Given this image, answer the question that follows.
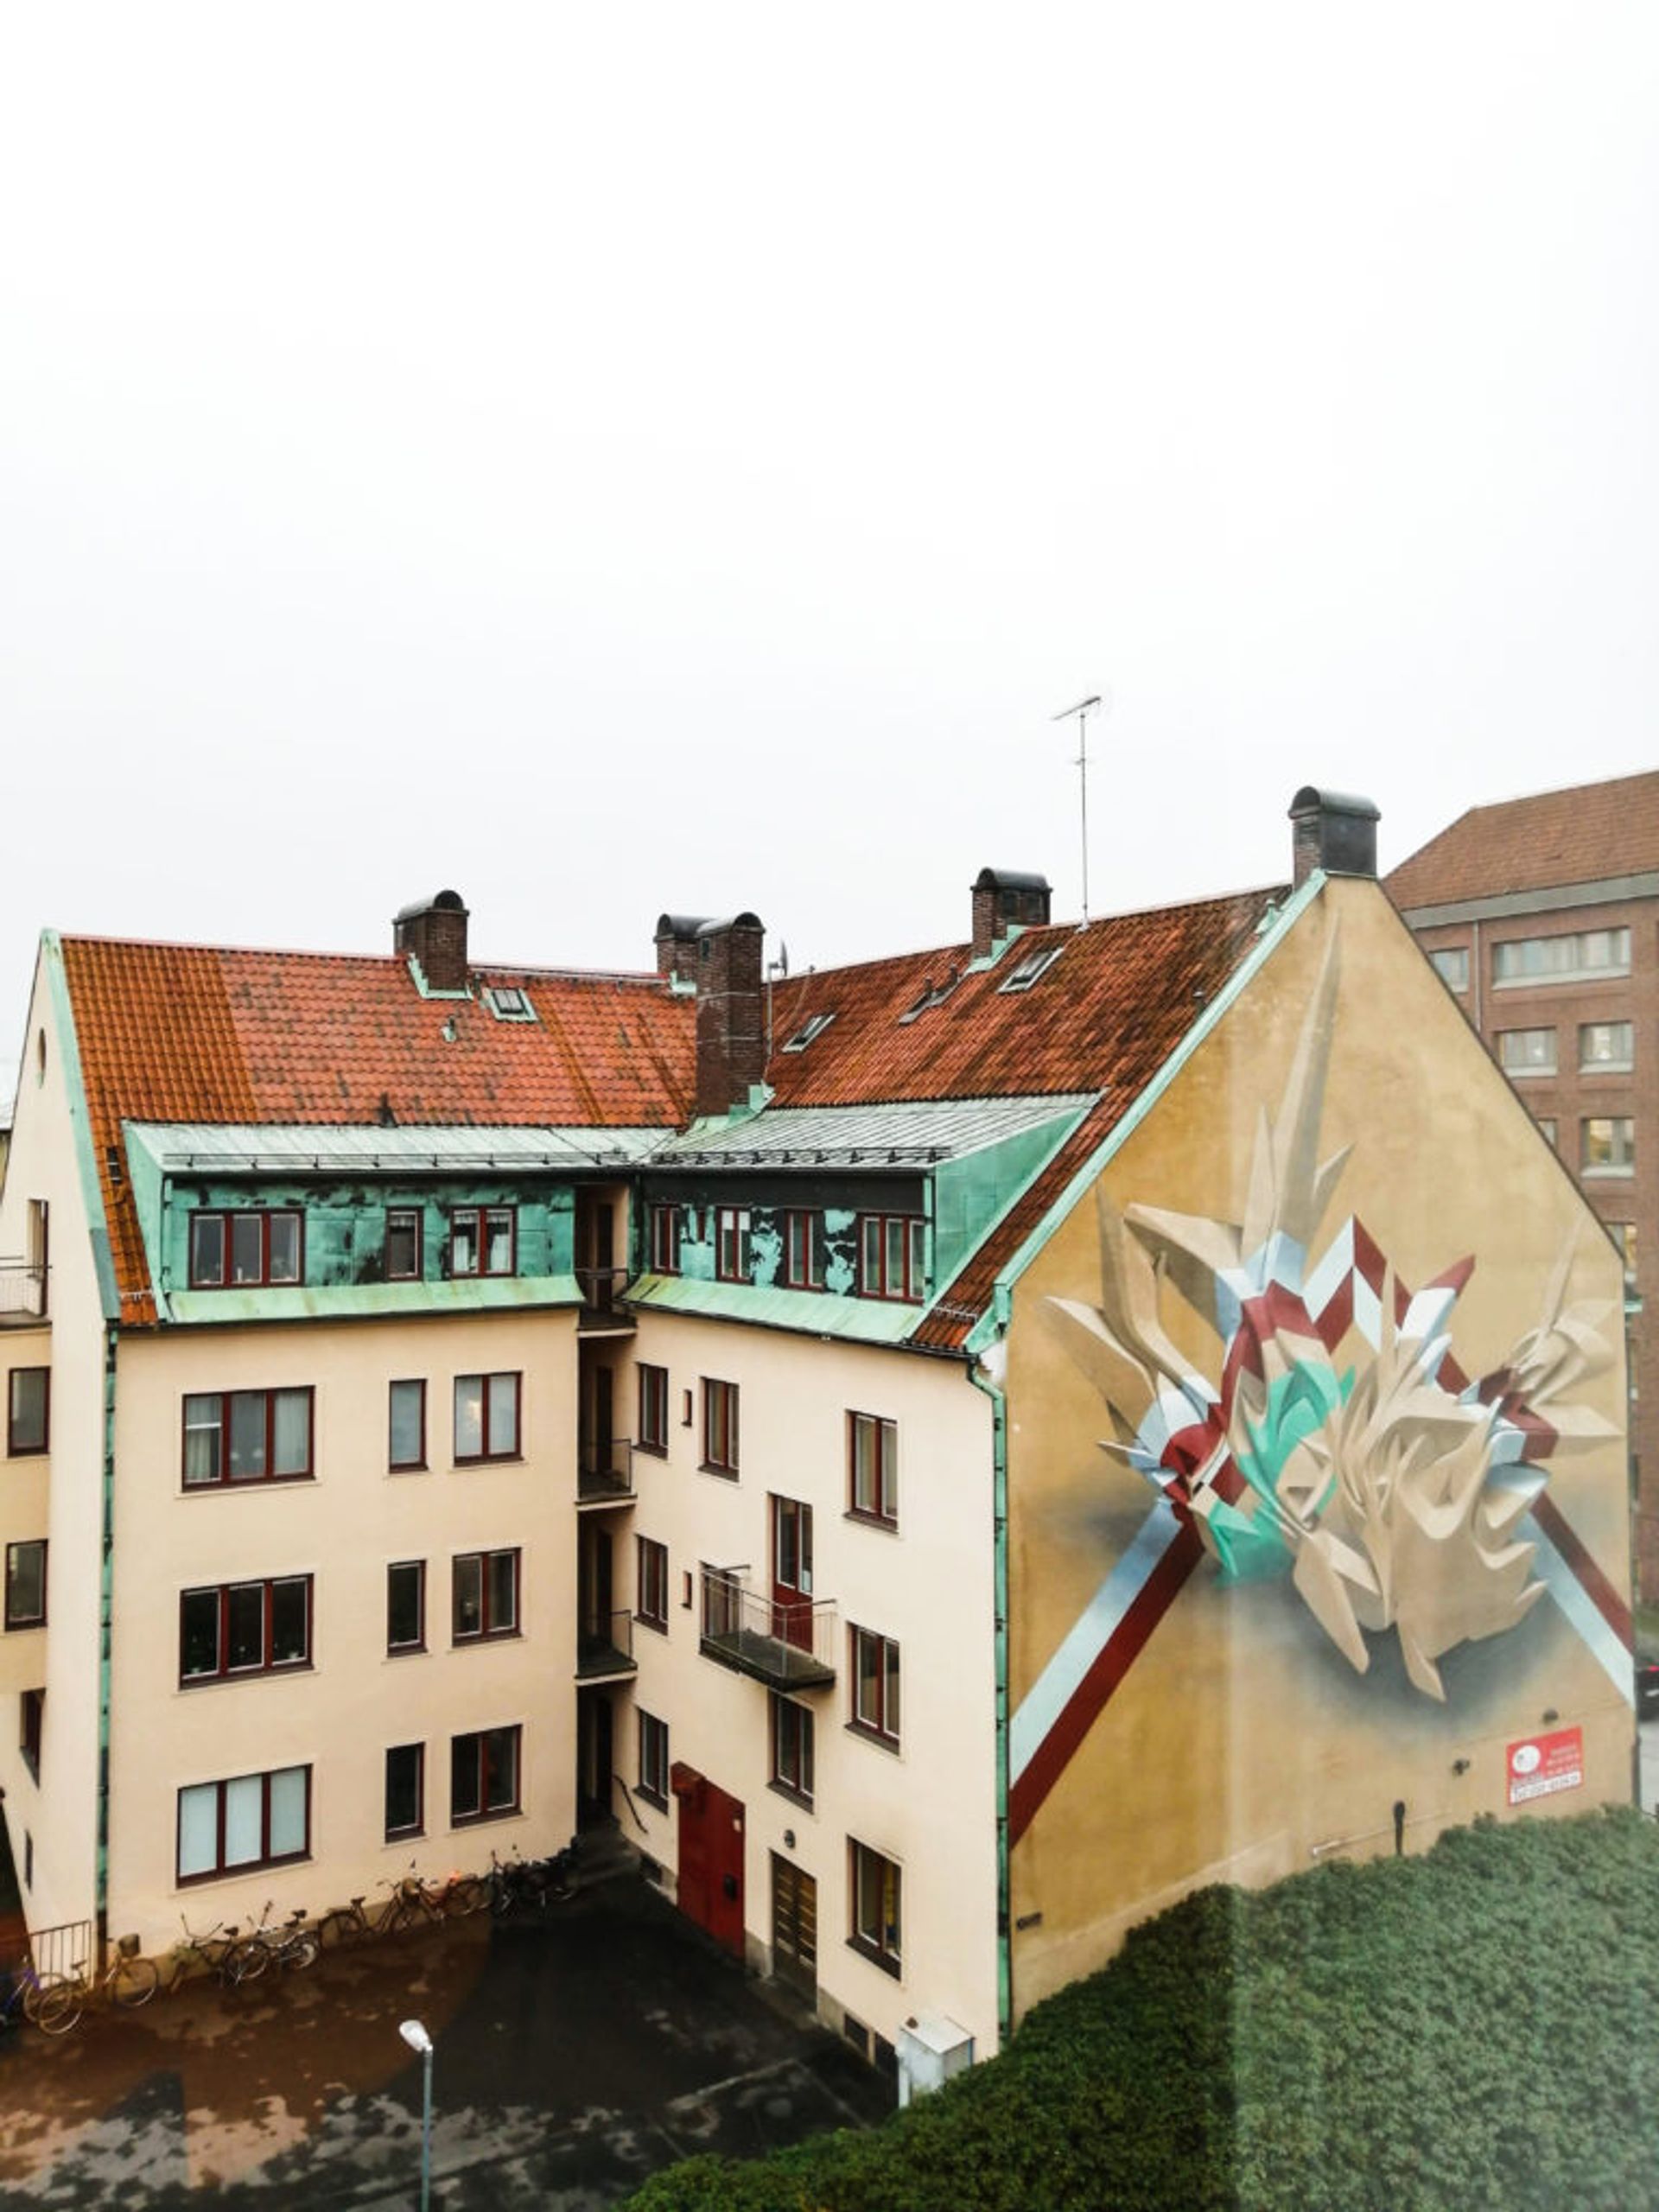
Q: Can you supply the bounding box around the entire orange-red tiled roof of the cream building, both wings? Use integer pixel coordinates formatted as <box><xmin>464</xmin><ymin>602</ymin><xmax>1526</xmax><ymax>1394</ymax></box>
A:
<box><xmin>62</xmin><ymin>887</ymin><xmax>1285</xmax><ymax>1351</ymax></box>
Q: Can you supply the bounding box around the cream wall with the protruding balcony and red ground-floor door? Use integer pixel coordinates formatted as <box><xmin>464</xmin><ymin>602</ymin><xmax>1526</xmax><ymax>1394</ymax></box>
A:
<box><xmin>617</xmin><ymin>1316</ymin><xmax>998</xmax><ymax>2055</ymax></box>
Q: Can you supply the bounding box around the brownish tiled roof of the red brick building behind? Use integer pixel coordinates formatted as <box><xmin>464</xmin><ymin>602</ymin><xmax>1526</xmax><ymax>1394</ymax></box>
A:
<box><xmin>1387</xmin><ymin>770</ymin><xmax>1659</xmax><ymax>909</ymax></box>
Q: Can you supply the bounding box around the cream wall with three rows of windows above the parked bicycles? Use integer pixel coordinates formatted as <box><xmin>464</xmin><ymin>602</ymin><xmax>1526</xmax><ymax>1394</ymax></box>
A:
<box><xmin>111</xmin><ymin>1312</ymin><xmax>577</xmax><ymax>1948</ymax></box>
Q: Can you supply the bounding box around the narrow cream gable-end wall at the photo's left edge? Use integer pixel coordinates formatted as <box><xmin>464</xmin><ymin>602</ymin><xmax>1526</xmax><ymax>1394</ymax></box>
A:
<box><xmin>0</xmin><ymin>956</ymin><xmax>104</xmax><ymax>1929</ymax></box>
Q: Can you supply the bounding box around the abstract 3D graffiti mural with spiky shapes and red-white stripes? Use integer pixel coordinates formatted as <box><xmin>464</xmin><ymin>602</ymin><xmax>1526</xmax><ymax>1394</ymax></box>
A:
<box><xmin>1011</xmin><ymin>931</ymin><xmax>1630</xmax><ymax>1838</ymax></box>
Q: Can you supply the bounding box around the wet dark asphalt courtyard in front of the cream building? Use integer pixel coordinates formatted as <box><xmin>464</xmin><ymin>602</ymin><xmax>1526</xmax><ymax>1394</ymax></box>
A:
<box><xmin>0</xmin><ymin>1876</ymin><xmax>892</xmax><ymax>2212</ymax></box>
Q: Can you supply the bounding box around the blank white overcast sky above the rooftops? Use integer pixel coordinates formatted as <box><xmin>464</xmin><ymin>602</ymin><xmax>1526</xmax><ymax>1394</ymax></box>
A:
<box><xmin>0</xmin><ymin>0</ymin><xmax>1659</xmax><ymax>1097</ymax></box>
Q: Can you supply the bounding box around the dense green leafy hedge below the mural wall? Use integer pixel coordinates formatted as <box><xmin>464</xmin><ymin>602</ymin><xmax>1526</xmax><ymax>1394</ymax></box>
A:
<box><xmin>628</xmin><ymin>1812</ymin><xmax>1659</xmax><ymax>2212</ymax></box>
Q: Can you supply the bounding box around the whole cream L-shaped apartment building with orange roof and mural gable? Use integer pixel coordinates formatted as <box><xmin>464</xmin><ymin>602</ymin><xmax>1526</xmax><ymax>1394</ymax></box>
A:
<box><xmin>0</xmin><ymin>791</ymin><xmax>1632</xmax><ymax>2086</ymax></box>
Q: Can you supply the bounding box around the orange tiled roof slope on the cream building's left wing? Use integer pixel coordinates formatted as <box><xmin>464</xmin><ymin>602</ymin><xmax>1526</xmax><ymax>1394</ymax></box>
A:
<box><xmin>62</xmin><ymin>938</ymin><xmax>695</xmax><ymax>1320</ymax></box>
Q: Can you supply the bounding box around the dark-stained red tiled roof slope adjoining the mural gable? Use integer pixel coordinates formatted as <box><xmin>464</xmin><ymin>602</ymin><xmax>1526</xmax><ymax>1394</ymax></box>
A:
<box><xmin>767</xmin><ymin>887</ymin><xmax>1285</xmax><ymax>1351</ymax></box>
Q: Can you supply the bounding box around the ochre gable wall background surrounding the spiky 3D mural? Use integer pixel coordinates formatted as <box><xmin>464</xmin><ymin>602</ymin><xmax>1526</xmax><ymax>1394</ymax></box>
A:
<box><xmin>1008</xmin><ymin>882</ymin><xmax>1635</xmax><ymax>2011</ymax></box>
